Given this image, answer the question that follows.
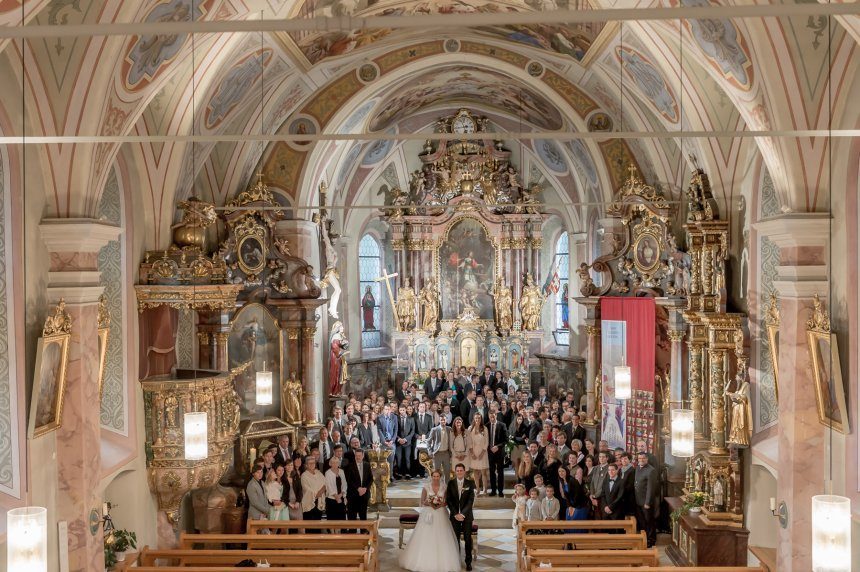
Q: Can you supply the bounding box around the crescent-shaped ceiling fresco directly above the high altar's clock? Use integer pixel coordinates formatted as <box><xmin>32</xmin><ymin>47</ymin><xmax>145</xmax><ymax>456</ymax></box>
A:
<box><xmin>370</xmin><ymin>66</ymin><xmax>563</xmax><ymax>131</ymax></box>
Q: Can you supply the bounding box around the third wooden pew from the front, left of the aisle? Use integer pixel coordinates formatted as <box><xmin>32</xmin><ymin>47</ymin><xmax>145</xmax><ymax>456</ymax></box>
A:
<box><xmin>137</xmin><ymin>548</ymin><xmax>368</xmax><ymax>572</ymax></box>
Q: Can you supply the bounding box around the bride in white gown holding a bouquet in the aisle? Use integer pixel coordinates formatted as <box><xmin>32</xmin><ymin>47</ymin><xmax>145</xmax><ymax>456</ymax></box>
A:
<box><xmin>400</xmin><ymin>469</ymin><xmax>460</xmax><ymax>572</ymax></box>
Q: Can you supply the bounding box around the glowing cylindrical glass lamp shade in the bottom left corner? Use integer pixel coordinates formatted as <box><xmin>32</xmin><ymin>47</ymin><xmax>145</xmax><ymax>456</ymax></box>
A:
<box><xmin>6</xmin><ymin>506</ymin><xmax>48</xmax><ymax>572</ymax></box>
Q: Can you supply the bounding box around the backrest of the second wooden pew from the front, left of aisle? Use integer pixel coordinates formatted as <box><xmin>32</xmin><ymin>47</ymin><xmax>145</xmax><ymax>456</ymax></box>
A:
<box><xmin>179</xmin><ymin>533</ymin><xmax>373</xmax><ymax>550</ymax></box>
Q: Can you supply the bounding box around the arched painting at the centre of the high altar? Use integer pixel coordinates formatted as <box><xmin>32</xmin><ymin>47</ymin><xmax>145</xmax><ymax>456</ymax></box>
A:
<box><xmin>439</xmin><ymin>218</ymin><xmax>496</xmax><ymax>320</ymax></box>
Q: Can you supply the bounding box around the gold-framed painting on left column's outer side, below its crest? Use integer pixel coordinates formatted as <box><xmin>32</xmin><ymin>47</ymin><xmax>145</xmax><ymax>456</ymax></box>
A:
<box><xmin>30</xmin><ymin>334</ymin><xmax>71</xmax><ymax>437</ymax></box>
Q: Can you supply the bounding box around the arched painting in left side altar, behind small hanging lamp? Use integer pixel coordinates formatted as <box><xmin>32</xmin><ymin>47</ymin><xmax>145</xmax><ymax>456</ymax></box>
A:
<box><xmin>227</xmin><ymin>304</ymin><xmax>281</xmax><ymax>417</ymax></box>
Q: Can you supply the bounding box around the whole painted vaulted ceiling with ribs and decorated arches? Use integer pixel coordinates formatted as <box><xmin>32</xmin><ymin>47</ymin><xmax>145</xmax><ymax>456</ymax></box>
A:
<box><xmin>0</xmin><ymin>0</ymin><xmax>860</xmax><ymax>246</ymax></box>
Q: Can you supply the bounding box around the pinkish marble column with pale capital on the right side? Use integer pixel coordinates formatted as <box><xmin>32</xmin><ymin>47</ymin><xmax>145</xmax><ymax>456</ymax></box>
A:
<box><xmin>755</xmin><ymin>213</ymin><xmax>832</xmax><ymax>572</ymax></box>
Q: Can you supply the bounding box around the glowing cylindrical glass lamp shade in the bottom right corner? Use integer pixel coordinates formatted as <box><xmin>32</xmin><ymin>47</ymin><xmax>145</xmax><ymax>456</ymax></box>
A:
<box><xmin>812</xmin><ymin>495</ymin><xmax>851</xmax><ymax>572</ymax></box>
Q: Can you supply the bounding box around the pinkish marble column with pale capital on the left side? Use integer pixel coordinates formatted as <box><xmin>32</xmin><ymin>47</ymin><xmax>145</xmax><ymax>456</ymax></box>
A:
<box><xmin>39</xmin><ymin>219</ymin><xmax>121</xmax><ymax>572</ymax></box>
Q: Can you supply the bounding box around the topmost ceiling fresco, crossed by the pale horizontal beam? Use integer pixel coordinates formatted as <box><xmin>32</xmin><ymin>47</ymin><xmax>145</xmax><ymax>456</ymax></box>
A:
<box><xmin>289</xmin><ymin>0</ymin><xmax>604</xmax><ymax>64</ymax></box>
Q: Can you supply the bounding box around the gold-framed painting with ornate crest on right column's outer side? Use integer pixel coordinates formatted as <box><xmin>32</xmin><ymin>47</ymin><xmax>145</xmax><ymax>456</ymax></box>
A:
<box><xmin>806</xmin><ymin>295</ymin><xmax>849</xmax><ymax>434</ymax></box>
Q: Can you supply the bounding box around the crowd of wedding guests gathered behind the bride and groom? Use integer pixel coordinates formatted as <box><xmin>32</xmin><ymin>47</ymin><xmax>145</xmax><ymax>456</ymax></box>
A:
<box><xmin>246</xmin><ymin>366</ymin><xmax>660</xmax><ymax>547</ymax></box>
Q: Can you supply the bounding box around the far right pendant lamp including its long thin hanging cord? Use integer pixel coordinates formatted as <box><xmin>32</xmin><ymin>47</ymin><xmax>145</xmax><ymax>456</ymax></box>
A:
<box><xmin>812</xmin><ymin>12</ymin><xmax>851</xmax><ymax>572</ymax></box>
